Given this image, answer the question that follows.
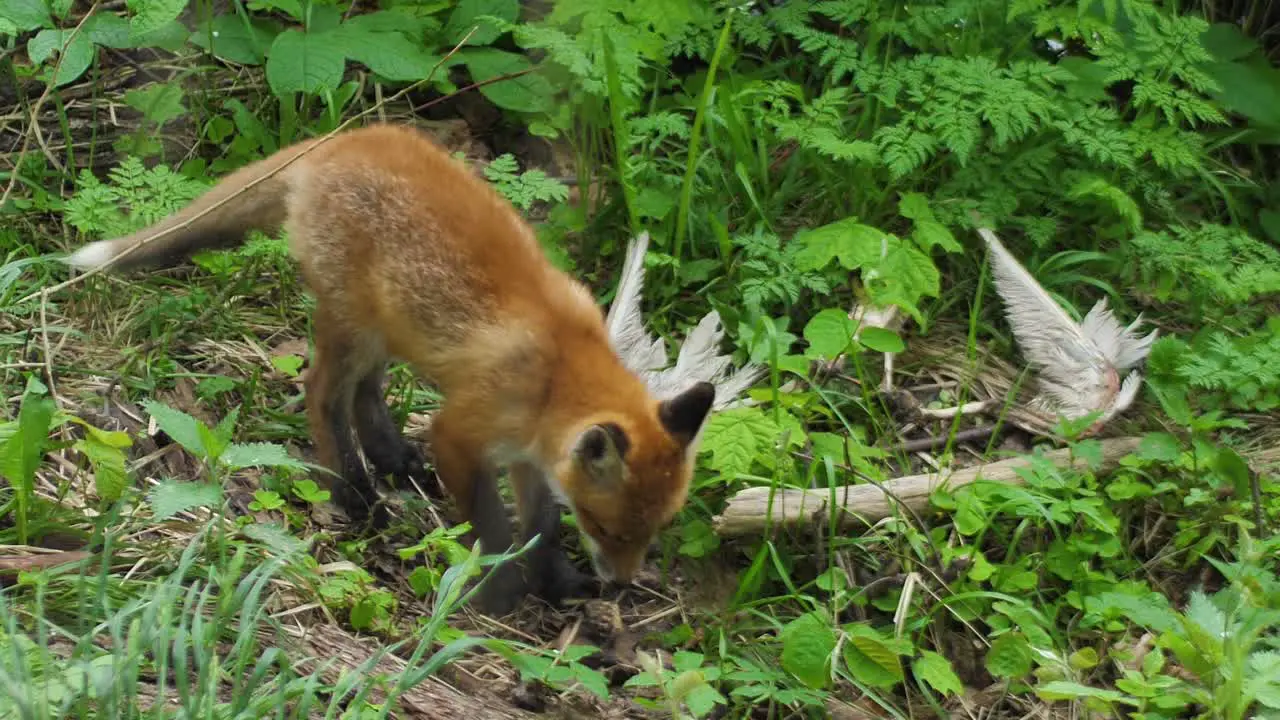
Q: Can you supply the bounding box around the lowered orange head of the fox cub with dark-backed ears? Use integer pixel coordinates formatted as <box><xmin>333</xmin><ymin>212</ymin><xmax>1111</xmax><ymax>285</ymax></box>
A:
<box><xmin>557</xmin><ymin>382</ymin><xmax>716</xmax><ymax>583</ymax></box>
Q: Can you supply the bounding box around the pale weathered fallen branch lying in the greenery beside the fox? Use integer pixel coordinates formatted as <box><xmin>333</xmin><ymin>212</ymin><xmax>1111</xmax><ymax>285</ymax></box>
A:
<box><xmin>712</xmin><ymin>437</ymin><xmax>1140</xmax><ymax>537</ymax></box>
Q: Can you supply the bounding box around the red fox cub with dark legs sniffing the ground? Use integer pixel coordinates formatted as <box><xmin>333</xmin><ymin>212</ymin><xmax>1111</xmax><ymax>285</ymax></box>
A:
<box><xmin>68</xmin><ymin>126</ymin><xmax>716</xmax><ymax>614</ymax></box>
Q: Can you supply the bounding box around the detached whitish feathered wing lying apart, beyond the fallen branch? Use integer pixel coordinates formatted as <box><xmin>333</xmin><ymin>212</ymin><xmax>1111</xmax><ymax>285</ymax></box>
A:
<box><xmin>978</xmin><ymin>222</ymin><xmax>1156</xmax><ymax>427</ymax></box>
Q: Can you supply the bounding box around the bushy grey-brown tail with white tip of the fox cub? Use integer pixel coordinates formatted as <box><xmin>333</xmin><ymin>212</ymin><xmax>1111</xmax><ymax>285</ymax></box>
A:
<box><xmin>65</xmin><ymin>140</ymin><xmax>319</xmax><ymax>270</ymax></box>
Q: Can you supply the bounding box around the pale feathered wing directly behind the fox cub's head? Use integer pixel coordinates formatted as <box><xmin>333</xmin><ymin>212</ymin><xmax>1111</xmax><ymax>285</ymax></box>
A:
<box><xmin>605</xmin><ymin>233</ymin><xmax>767</xmax><ymax>410</ymax></box>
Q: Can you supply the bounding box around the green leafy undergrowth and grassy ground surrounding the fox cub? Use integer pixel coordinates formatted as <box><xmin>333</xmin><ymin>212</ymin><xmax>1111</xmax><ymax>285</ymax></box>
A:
<box><xmin>0</xmin><ymin>0</ymin><xmax>1280</xmax><ymax>719</ymax></box>
